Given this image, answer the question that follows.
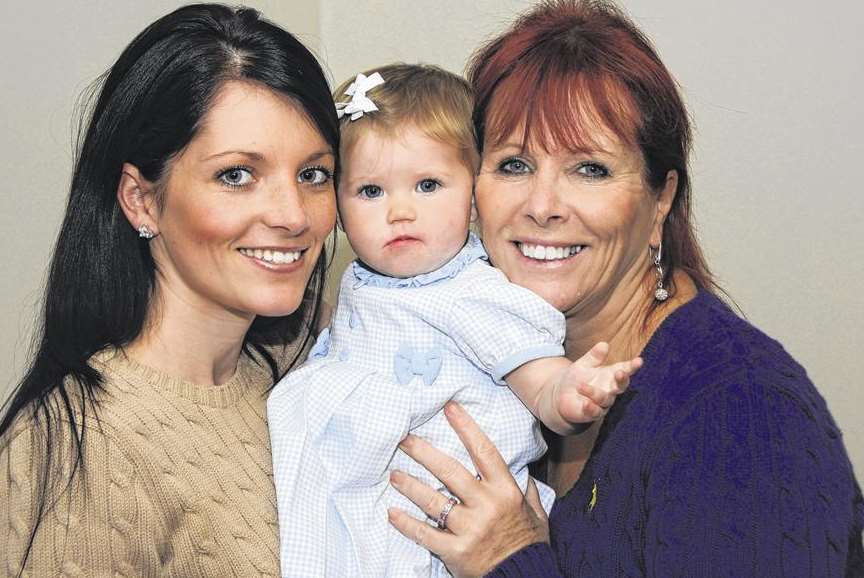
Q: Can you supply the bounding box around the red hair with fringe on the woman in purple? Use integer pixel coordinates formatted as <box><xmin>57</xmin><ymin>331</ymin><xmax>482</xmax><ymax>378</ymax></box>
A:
<box><xmin>467</xmin><ymin>0</ymin><xmax>719</xmax><ymax>304</ymax></box>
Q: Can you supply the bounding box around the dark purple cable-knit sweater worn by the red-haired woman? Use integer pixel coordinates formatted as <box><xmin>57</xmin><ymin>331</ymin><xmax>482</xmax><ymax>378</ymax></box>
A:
<box><xmin>490</xmin><ymin>291</ymin><xmax>864</xmax><ymax>578</ymax></box>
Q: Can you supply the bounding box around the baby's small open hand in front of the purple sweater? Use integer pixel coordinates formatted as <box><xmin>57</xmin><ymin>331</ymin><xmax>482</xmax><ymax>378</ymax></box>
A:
<box><xmin>558</xmin><ymin>341</ymin><xmax>642</xmax><ymax>424</ymax></box>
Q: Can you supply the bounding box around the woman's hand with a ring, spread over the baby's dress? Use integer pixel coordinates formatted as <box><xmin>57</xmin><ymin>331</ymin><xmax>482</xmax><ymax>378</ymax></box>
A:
<box><xmin>389</xmin><ymin>402</ymin><xmax>549</xmax><ymax>577</ymax></box>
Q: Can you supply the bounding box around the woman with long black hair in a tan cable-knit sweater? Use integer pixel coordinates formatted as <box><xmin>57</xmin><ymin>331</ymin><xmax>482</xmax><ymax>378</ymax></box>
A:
<box><xmin>0</xmin><ymin>4</ymin><xmax>339</xmax><ymax>576</ymax></box>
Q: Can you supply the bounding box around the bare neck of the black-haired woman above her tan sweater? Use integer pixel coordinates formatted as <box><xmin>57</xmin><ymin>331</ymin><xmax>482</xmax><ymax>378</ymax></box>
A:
<box><xmin>125</xmin><ymin>281</ymin><xmax>254</xmax><ymax>385</ymax></box>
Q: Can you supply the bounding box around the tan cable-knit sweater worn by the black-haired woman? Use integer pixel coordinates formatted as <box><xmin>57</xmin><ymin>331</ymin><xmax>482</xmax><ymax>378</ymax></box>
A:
<box><xmin>0</xmin><ymin>344</ymin><xmax>290</xmax><ymax>577</ymax></box>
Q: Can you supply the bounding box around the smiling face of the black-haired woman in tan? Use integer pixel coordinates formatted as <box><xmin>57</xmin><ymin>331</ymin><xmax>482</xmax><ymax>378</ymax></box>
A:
<box><xmin>150</xmin><ymin>82</ymin><xmax>336</xmax><ymax>318</ymax></box>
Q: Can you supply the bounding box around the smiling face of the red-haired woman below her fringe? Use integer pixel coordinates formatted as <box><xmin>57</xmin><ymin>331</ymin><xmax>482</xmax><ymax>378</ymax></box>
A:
<box><xmin>476</xmin><ymin>126</ymin><xmax>676</xmax><ymax>315</ymax></box>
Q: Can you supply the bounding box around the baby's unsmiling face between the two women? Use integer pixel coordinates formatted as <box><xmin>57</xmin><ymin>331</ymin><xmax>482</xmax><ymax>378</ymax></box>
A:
<box><xmin>337</xmin><ymin>127</ymin><xmax>474</xmax><ymax>277</ymax></box>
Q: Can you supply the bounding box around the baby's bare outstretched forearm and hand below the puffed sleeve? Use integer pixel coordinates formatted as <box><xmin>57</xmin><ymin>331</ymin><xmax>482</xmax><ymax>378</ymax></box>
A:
<box><xmin>505</xmin><ymin>342</ymin><xmax>642</xmax><ymax>435</ymax></box>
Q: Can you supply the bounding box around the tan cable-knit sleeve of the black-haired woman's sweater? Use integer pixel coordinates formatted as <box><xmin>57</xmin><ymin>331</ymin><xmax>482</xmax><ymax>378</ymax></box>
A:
<box><xmin>0</xmin><ymin>412</ymin><xmax>166</xmax><ymax>577</ymax></box>
